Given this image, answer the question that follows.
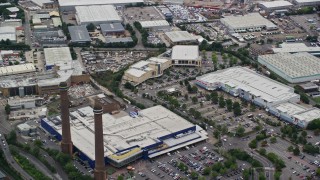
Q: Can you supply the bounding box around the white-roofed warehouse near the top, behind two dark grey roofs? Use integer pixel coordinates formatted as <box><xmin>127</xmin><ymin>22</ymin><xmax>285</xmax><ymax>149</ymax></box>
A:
<box><xmin>76</xmin><ymin>5</ymin><xmax>122</xmax><ymax>25</ymax></box>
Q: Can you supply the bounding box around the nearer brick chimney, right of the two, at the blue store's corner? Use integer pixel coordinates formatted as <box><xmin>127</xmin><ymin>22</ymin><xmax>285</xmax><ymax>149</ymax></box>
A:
<box><xmin>93</xmin><ymin>103</ymin><xmax>107</xmax><ymax>180</ymax></box>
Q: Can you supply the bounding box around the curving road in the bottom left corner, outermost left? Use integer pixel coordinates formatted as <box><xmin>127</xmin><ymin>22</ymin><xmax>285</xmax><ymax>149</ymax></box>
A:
<box><xmin>0</xmin><ymin>135</ymin><xmax>33</xmax><ymax>180</ymax></box>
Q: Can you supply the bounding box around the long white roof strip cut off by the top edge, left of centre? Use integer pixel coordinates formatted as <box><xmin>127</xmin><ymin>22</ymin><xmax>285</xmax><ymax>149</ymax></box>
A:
<box><xmin>58</xmin><ymin>0</ymin><xmax>144</xmax><ymax>6</ymax></box>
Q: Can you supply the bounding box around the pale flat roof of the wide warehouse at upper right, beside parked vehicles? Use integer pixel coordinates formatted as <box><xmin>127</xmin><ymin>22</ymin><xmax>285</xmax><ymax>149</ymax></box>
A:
<box><xmin>221</xmin><ymin>13</ymin><xmax>277</xmax><ymax>29</ymax></box>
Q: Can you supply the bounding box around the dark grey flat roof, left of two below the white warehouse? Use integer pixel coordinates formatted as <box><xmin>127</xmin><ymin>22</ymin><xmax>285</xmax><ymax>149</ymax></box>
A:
<box><xmin>68</xmin><ymin>26</ymin><xmax>91</xmax><ymax>42</ymax></box>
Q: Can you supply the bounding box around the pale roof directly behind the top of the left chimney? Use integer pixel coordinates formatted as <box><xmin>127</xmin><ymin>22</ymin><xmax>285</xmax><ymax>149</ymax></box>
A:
<box><xmin>44</xmin><ymin>47</ymin><xmax>72</xmax><ymax>69</ymax></box>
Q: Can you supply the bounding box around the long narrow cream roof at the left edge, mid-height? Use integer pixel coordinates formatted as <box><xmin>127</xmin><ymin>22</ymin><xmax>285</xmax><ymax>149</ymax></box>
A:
<box><xmin>0</xmin><ymin>63</ymin><xmax>36</xmax><ymax>76</ymax></box>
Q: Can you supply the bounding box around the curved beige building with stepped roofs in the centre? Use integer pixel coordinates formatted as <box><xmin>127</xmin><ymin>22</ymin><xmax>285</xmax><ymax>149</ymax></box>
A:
<box><xmin>123</xmin><ymin>57</ymin><xmax>171</xmax><ymax>85</ymax></box>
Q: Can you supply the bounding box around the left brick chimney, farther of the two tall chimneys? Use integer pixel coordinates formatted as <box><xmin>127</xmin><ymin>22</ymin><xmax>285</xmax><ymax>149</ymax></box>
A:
<box><xmin>59</xmin><ymin>82</ymin><xmax>73</xmax><ymax>156</ymax></box>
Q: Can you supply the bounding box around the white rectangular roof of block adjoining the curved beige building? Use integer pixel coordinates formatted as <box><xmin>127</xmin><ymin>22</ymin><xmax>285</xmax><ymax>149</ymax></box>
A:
<box><xmin>171</xmin><ymin>45</ymin><xmax>200</xmax><ymax>60</ymax></box>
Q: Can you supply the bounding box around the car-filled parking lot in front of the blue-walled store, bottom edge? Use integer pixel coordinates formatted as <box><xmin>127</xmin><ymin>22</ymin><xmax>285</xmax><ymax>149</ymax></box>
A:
<box><xmin>135</xmin><ymin>143</ymin><xmax>247</xmax><ymax>180</ymax></box>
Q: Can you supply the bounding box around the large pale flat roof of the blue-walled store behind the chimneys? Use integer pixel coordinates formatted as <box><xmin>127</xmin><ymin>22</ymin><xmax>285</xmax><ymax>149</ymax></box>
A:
<box><xmin>43</xmin><ymin>105</ymin><xmax>202</xmax><ymax>160</ymax></box>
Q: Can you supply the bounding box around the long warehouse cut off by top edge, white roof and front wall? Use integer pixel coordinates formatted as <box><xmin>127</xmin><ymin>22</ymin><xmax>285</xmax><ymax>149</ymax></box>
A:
<box><xmin>58</xmin><ymin>0</ymin><xmax>144</xmax><ymax>11</ymax></box>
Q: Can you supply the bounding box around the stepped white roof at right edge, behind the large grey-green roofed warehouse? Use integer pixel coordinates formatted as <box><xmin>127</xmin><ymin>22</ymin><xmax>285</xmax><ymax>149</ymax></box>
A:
<box><xmin>272</xmin><ymin>43</ymin><xmax>320</xmax><ymax>53</ymax></box>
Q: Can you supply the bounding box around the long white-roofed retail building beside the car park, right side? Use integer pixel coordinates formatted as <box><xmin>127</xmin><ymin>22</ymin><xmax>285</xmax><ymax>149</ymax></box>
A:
<box><xmin>196</xmin><ymin>67</ymin><xmax>320</xmax><ymax>128</ymax></box>
